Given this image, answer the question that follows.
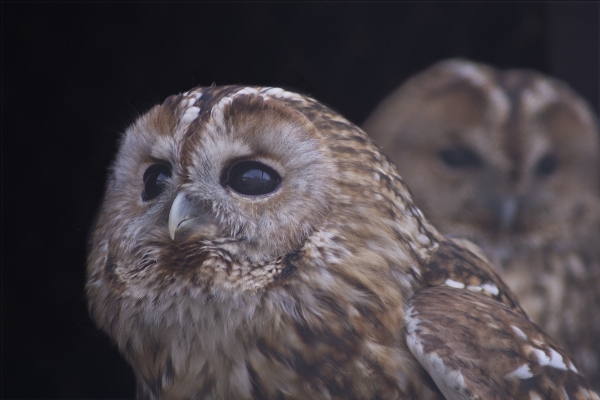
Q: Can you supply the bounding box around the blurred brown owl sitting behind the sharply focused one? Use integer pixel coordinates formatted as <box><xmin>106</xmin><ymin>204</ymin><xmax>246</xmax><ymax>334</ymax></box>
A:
<box><xmin>364</xmin><ymin>60</ymin><xmax>600</xmax><ymax>388</ymax></box>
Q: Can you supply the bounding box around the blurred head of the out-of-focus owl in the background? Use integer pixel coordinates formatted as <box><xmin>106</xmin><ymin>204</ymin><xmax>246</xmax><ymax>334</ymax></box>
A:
<box><xmin>364</xmin><ymin>60</ymin><xmax>599</xmax><ymax>242</ymax></box>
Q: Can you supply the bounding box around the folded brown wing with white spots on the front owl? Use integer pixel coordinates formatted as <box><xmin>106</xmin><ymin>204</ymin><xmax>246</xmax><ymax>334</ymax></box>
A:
<box><xmin>405</xmin><ymin>243</ymin><xmax>599</xmax><ymax>400</ymax></box>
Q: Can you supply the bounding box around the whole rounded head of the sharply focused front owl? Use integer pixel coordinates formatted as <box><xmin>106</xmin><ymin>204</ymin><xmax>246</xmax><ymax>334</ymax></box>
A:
<box><xmin>87</xmin><ymin>86</ymin><xmax>436</xmax><ymax>347</ymax></box>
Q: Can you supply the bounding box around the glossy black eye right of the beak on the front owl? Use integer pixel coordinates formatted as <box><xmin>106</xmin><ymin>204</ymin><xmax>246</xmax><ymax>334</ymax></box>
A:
<box><xmin>225</xmin><ymin>161</ymin><xmax>281</xmax><ymax>196</ymax></box>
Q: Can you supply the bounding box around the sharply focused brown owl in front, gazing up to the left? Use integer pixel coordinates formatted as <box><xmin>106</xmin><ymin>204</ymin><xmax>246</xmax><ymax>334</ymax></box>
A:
<box><xmin>86</xmin><ymin>85</ymin><xmax>599</xmax><ymax>399</ymax></box>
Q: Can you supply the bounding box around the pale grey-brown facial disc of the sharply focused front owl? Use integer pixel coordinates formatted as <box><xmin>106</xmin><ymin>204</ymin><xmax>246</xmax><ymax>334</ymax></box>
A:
<box><xmin>107</xmin><ymin>88</ymin><xmax>334</xmax><ymax>272</ymax></box>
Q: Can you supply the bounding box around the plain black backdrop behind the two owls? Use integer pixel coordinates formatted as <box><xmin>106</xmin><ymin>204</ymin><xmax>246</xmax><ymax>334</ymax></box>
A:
<box><xmin>1</xmin><ymin>2</ymin><xmax>600</xmax><ymax>398</ymax></box>
